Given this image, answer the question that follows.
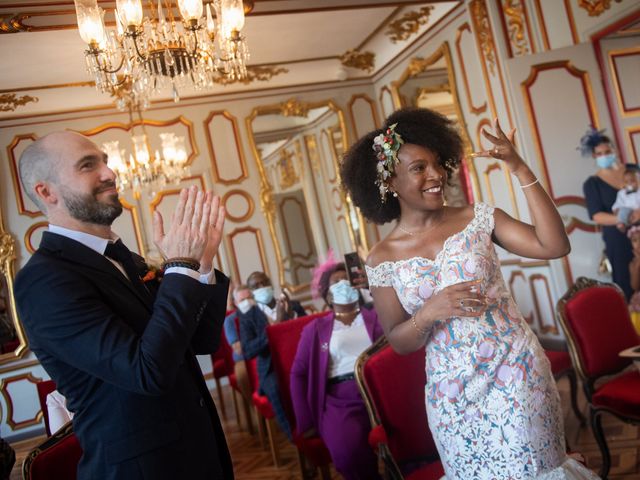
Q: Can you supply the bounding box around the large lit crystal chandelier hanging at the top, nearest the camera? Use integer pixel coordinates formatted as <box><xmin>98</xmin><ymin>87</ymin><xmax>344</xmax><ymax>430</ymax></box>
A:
<box><xmin>74</xmin><ymin>0</ymin><xmax>252</xmax><ymax>109</ymax></box>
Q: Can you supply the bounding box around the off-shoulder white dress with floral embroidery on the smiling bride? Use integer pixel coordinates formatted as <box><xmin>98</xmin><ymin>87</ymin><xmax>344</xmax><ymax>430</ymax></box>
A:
<box><xmin>367</xmin><ymin>203</ymin><xmax>598</xmax><ymax>480</ymax></box>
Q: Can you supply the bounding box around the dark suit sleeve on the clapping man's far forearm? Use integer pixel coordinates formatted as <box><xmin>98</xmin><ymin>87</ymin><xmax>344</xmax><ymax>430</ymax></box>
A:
<box><xmin>191</xmin><ymin>270</ymin><xmax>229</xmax><ymax>355</ymax></box>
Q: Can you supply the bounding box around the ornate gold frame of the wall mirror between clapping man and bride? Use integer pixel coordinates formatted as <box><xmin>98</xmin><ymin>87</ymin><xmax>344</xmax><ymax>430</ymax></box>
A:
<box><xmin>245</xmin><ymin>98</ymin><xmax>358</xmax><ymax>293</ymax></box>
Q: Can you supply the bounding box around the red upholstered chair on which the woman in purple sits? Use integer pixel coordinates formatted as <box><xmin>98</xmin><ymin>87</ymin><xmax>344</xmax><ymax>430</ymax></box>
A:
<box><xmin>267</xmin><ymin>312</ymin><xmax>331</xmax><ymax>480</ymax></box>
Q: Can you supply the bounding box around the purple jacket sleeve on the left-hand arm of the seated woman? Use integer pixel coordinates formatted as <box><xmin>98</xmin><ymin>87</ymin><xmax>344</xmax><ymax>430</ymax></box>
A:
<box><xmin>290</xmin><ymin>323</ymin><xmax>315</xmax><ymax>434</ymax></box>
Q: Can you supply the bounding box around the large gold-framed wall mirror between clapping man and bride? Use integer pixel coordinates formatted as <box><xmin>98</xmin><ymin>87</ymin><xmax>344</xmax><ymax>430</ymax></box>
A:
<box><xmin>246</xmin><ymin>99</ymin><xmax>367</xmax><ymax>294</ymax></box>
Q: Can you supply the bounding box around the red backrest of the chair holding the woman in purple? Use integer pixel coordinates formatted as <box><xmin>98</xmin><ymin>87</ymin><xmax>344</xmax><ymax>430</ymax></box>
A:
<box><xmin>267</xmin><ymin>312</ymin><xmax>327</xmax><ymax>429</ymax></box>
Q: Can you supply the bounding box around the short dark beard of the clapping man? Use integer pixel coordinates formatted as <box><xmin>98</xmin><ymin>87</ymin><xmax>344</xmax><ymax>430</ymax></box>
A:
<box><xmin>61</xmin><ymin>182</ymin><xmax>122</xmax><ymax>225</ymax></box>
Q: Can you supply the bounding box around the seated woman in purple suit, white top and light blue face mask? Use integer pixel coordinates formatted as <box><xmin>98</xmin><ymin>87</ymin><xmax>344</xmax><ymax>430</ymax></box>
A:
<box><xmin>291</xmin><ymin>260</ymin><xmax>383</xmax><ymax>480</ymax></box>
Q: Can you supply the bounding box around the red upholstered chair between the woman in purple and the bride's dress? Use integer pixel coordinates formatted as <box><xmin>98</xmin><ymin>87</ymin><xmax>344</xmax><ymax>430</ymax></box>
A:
<box><xmin>356</xmin><ymin>337</ymin><xmax>444</xmax><ymax>480</ymax></box>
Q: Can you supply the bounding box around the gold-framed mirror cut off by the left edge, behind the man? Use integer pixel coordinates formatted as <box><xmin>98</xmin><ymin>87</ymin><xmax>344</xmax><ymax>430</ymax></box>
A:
<box><xmin>0</xmin><ymin>208</ymin><xmax>27</xmax><ymax>363</ymax></box>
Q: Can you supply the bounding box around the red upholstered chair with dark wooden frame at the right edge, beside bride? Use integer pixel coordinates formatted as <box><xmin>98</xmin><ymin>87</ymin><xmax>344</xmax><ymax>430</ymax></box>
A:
<box><xmin>557</xmin><ymin>277</ymin><xmax>640</xmax><ymax>480</ymax></box>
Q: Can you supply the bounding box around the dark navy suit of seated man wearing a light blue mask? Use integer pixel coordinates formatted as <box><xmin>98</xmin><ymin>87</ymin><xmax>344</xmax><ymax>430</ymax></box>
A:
<box><xmin>238</xmin><ymin>296</ymin><xmax>291</xmax><ymax>438</ymax></box>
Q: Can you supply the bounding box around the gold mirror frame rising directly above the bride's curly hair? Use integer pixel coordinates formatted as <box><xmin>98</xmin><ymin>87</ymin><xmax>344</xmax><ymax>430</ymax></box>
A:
<box><xmin>391</xmin><ymin>42</ymin><xmax>481</xmax><ymax>197</ymax></box>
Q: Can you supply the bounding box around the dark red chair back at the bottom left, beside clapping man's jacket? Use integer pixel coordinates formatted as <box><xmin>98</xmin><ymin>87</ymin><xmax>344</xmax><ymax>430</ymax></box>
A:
<box><xmin>22</xmin><ymin>422</ymin><xmax>82</xmax><ymax>480</ymax></box>
